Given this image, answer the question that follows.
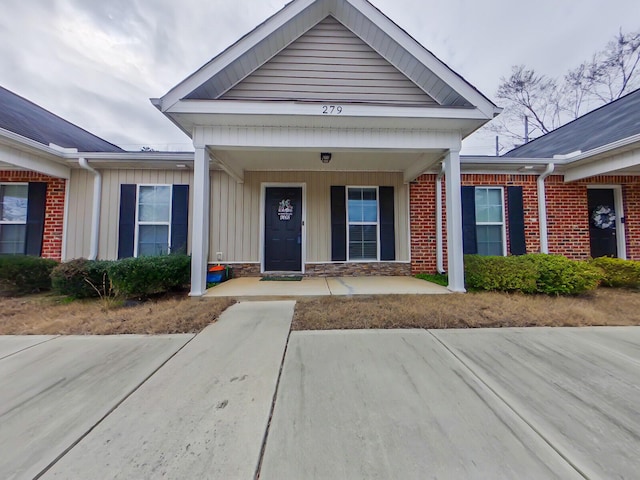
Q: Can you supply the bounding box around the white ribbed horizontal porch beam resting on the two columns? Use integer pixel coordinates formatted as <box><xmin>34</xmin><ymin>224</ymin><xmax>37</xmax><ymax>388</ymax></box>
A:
<box><xmin>194</xmin><ymin>126</ymin><xmax>460</xmax><ymax>151</ymax></box>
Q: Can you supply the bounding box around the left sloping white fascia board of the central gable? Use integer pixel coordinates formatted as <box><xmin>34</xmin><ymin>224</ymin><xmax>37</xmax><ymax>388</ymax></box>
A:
<box><xmin>158</xmin><ymin>0</ymin><xmax>317</xmax><ymax>112</ymax></box>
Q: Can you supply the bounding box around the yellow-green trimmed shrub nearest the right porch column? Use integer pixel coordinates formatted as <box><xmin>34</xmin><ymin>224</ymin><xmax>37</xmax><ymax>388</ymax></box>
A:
<box><xmin>464</xmin><ymin>255</ymin><xmax>537</xmax><ymax>293</ymax></box>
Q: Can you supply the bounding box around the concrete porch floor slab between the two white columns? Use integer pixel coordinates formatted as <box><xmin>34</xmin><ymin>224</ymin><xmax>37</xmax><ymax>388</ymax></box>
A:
<box><xmin>204</xmin><ymin>277</ymin><xmax>451</xmax><ymax>298</ymax></box>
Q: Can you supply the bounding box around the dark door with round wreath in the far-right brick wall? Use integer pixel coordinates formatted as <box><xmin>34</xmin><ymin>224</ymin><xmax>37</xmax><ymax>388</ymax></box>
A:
<box><xmin>587</xmin><ymin>188</ymin><xmax>618</xmax><ymax>258</ymax></box>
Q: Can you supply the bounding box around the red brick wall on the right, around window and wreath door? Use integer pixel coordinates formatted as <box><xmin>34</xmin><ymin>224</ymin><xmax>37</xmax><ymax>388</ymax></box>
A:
<box><xmin>410</xmin><ymin>174</ymin><xmax>640</xmax><ymax>274</ymax></box>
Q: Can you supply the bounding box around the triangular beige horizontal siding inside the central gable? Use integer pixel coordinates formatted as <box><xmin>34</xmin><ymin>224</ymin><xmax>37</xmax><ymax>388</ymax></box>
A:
<box><xmin>220</xmin><ymin>17</ymin><xmax>437</xmax><ymax>106</ymax></box>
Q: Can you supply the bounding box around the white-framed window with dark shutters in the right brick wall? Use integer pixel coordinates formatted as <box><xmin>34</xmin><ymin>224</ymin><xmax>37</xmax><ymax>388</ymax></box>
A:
<box><xmin>475</xmin><ymin>187</ymin><xmax>507</xmax><ymax>255</ymax></box>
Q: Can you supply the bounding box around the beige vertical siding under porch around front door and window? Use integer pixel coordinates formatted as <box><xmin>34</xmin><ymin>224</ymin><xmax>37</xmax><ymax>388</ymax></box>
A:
<box><xmin>209</xmin><ymin>171</ymin><xmax>409</xmax><ymax>262</ymax></box>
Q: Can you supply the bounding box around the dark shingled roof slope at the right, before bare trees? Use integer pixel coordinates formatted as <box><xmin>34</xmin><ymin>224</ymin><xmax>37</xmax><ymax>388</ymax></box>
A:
<box><xmin>503</xmin><ymin>89</ymin><xmax>640</xmax><ymax>158</ymax></box>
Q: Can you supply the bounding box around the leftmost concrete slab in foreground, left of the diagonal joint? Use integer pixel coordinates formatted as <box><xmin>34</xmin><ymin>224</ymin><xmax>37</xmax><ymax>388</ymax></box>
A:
<box><xmin>0</xmin><ymin>335</ymin><xmax>193</xmax><ymax>479</ymax></box>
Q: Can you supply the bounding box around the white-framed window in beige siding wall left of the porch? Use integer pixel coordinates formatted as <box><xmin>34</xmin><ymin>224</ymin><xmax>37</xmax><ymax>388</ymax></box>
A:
<box><xmin>134</xmin><ymin>185</ymin><xmax>173</xmax><ymax>257</ymax></box>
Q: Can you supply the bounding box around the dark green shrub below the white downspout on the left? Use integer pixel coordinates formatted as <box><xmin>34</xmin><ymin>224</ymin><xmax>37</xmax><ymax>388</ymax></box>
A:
<box><xmin>51</xmin><ymin>258</ymin><xmax>114</xmax><ymax>298</ymax></box>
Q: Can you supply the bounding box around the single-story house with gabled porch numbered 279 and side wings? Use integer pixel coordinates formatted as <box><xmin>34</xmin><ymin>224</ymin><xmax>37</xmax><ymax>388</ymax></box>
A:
<box><xmin>0</xmin><ymin>0</ymin><xmax>640</xmax><ymax>296</ymax></box>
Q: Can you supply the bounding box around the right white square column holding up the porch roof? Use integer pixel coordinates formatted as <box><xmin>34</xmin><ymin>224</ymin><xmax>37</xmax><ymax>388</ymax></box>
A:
<box><xmin>444</xmin><ymin>150</ymin><xmax>466</xmax><ymax>292</ymax></box>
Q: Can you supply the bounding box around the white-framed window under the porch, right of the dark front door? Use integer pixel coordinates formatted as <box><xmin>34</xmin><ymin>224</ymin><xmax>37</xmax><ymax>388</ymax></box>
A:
<box><xmin>347</xmin><ymin>187</ymin><xmax>380</xmax><ymax>261</ymax></box>
